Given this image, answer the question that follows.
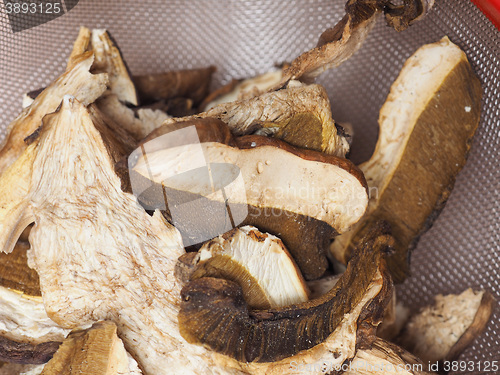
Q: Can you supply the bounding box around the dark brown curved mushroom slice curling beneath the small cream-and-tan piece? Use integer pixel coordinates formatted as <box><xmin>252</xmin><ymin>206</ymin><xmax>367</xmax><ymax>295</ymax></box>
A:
<box><xmin>179</xmin><ymin>223</ymin><xmax>392</xmax><ymax>366</ymax></box>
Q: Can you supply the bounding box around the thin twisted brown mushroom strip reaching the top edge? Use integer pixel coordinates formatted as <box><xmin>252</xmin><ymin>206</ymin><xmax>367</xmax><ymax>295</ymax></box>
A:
<box><xmin>275</xmin><ymin>0</ymin><xmax>434</xmax><ymax>89</ymax></box>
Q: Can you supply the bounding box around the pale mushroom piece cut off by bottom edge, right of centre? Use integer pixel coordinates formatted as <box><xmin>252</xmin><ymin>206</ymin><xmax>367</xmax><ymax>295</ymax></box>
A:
<box><xmin>342</xmin><ymin>338</ymin><xmax>433</xmax><ymax>375</ymax></box>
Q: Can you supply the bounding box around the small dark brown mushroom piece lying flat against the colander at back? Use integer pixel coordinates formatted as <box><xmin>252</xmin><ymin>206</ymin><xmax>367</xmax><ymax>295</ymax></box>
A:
<box><xmin>133</xmin><ymin>66</ymin><xmax>216</xmax><ymax>105</ymax></box>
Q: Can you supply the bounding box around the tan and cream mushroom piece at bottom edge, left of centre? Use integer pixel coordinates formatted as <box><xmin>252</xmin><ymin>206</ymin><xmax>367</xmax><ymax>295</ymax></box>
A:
<box><xmin>41</xmin><ymin>321</ymin><xmax>137</xmax><ymax>375</ymax></box>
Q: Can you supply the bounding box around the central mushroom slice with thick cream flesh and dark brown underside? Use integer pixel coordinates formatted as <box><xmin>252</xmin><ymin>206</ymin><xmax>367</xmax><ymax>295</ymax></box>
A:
<box><xmin>129</xmin><ymin>119</ymin><xmax>367</xmax><ymax>279</ymax></box>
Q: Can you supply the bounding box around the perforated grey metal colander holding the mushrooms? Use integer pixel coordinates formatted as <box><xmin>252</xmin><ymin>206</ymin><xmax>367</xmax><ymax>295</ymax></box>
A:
<box><xmin>0</xmin><ymin>0</ymin><xmax>500</xmax><ymax>373</ymax></box>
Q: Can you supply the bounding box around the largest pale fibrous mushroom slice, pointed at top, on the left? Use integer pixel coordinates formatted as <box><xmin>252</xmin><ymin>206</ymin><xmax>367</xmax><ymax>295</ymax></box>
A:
<box><xmin>0</xmin><ymin>97</ymin><xmax>378</xmax><ymax>375</ymax></box>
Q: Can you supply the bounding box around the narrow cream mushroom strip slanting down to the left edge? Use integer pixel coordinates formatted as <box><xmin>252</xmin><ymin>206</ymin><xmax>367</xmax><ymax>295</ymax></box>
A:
<box><xmin>0</xmin><ymin>52</ymin><xmax>108</xmax><ymax>174</ymax></box>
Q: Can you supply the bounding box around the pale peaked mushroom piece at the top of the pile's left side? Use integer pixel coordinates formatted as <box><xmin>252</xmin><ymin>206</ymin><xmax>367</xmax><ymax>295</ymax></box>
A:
<box><xmin>68</xmin><ymin>27</ymin><xmax>138</xmax><ymax>105</ymax></box>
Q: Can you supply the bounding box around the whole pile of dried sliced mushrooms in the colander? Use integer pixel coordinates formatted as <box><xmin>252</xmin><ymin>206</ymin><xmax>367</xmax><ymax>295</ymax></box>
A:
<box><xmin>0</xmin><ymin>0</ymin><xmax>493</xmax><ymax>374</ymax></box>
